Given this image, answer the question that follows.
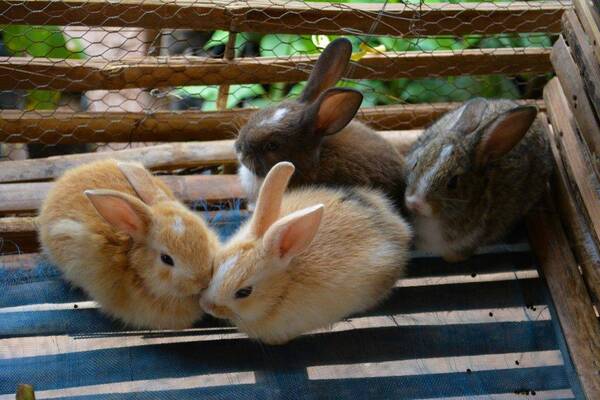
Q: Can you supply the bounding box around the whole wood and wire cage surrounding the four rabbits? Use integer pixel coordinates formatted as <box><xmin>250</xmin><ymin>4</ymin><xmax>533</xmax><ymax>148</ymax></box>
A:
<box><xmin>0</xmin><ymin>0</ymin><xmax>600</xmax><ymax>399</ymax></box>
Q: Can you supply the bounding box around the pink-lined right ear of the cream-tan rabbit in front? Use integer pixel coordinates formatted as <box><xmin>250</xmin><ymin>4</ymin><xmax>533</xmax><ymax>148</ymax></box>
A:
<box><xmin>263</xmin><ymin>204</ymin><xmax>324</xmax><ymax>260</ymax></box>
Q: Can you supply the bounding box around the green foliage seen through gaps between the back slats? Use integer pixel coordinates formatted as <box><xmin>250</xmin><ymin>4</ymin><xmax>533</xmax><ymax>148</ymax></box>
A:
<box><xmin>1</xmin><ymin>0</ymin><xmax>552</xmax><ymax>111</ymax></box>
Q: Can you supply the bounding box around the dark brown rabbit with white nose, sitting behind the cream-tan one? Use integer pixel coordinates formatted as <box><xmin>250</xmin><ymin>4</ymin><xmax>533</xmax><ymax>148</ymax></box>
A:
<box><xmin>234</xmin><ymin>38</ymin><xmax>404</xmax><ymax>208</ymax></box>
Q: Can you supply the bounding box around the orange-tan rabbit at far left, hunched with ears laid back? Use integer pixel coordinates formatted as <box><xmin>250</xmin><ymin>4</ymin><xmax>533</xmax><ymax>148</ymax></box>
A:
<box><xmin>37</xmin><ymin>160</ymin><xmax>219</xmax><ymax>329</ymax></box>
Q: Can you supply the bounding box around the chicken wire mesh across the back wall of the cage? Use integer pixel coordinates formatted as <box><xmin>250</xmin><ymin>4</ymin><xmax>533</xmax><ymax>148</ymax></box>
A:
<box><xmin>0</xmin><ymin>0</ymin><xmax>568</xmax><ymax>160</ymax></box>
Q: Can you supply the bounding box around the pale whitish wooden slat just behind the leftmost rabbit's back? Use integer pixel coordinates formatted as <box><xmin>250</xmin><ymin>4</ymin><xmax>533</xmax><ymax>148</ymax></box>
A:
<box><xmin>0</xmin><ymin>130</ymin><xmax>422</xmax><ymax>183</ymax></box>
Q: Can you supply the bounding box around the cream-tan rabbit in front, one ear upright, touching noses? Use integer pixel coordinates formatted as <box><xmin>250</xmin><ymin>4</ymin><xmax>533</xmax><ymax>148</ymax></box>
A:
<box><xmin>201</xmin><ymin>162</ymin><xmax>411</xmax><ymax>344</ymax></box>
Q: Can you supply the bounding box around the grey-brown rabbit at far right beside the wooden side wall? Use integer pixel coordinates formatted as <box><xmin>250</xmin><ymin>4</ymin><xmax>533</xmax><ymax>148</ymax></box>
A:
<box><xmin>405</xmin><ymin>98</ymin><xmax>552</xmax><ymax>262</ymax></box>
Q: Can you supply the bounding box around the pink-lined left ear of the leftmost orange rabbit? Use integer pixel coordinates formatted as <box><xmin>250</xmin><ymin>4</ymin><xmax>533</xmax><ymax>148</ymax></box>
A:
<box><xmin>84</xmin><ymin>190</ymin><xmax>152</xmax><ymax>241</ymax></box>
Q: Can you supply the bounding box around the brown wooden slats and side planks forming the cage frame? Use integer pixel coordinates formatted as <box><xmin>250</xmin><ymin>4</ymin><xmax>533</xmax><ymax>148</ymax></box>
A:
<box><xmin>0</xmin><ymin>0</ymin><xmax>600</xmax><ymax>399</ymax></box>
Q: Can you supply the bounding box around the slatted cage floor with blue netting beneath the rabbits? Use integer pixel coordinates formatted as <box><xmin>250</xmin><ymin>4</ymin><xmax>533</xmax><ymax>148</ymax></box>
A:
<box><xmin>0</xmin><ymin>214</ymin><xmax>580</xmax><ymax>400</ymax></box>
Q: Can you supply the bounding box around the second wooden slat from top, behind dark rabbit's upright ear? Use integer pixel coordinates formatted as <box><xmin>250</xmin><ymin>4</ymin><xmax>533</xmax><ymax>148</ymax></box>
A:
<box><xmin>0</xmin><ymin>48</ymin><xmax>552</xmax><ymax>91</ymax></box>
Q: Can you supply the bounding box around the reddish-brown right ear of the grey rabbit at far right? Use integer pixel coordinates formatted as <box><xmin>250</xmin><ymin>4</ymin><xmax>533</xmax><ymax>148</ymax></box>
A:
<box><xmin>475</xmin><ymin>106</ymin><xmax>537</xmax><ymax>165</ymax></box>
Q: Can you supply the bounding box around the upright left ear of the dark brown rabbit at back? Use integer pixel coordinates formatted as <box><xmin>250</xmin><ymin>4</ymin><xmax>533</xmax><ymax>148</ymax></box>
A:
<box><xmin>298</xmin><ymin>38</ymin><xmax>352</xmax><ymax>103</ymax></box>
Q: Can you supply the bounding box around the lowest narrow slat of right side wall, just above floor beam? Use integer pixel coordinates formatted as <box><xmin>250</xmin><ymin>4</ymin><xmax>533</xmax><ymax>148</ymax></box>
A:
<box><xmin>542</xmin><ymin>116</ymin><xmax>600</xmax><ymax>307</ymax></box>
